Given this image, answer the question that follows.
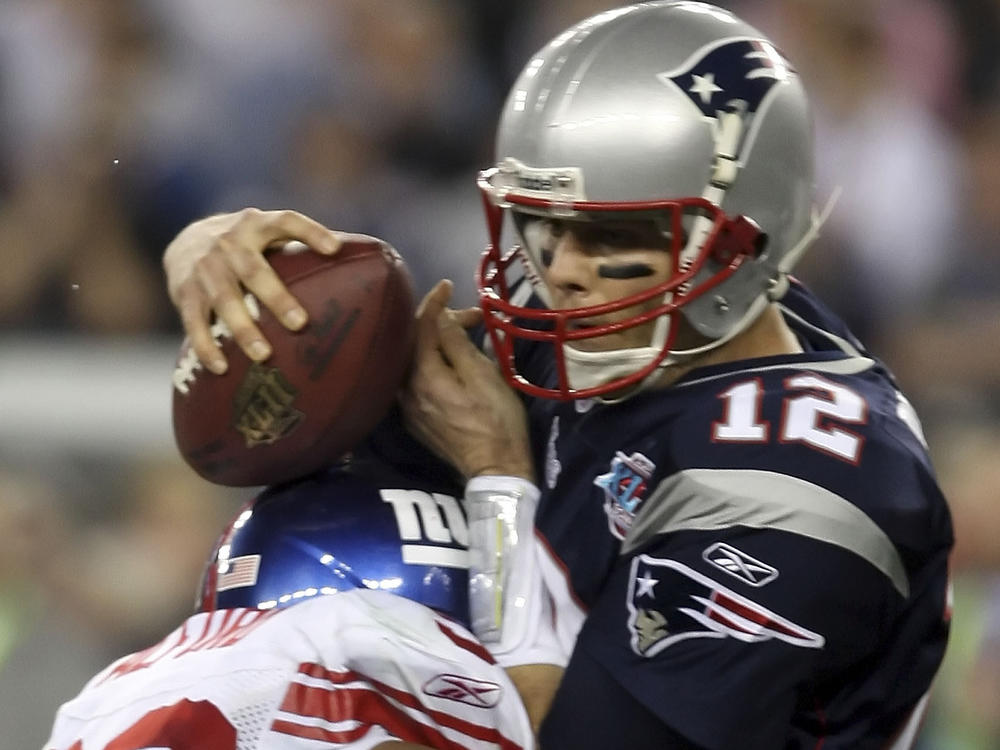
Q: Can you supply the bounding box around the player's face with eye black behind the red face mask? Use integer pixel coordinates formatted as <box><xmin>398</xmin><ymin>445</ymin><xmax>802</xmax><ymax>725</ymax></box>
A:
<box><xmin>524</xmin><ymin>219</ymin><xmax>673</xmax><ymax>351</ymax></box>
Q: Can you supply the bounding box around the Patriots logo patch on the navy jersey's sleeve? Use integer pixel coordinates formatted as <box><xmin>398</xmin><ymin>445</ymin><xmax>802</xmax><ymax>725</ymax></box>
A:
<box><xmin>628</xmin><ymin>555</ymin><xmax>826</xmax><ymax>657</ymax></box>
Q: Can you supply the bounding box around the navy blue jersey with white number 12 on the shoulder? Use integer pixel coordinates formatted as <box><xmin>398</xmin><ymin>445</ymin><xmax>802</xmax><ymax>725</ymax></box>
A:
<box><xmin>529</xmin><ymin>284</ymin><xmax>952</xmax><ymax>750</ymax></box>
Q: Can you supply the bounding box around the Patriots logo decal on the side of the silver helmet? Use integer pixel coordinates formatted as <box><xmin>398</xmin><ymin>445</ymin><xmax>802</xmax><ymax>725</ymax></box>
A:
<box><xmin>657</xmin><ymin>39</ymin><xmax>794</xmax><ymax>119</ymax></box>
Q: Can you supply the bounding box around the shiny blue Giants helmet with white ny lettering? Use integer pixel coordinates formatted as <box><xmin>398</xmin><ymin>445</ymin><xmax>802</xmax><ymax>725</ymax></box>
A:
<box><xmin>199</xmin><ymin>464</ymin><xmax>469</xmax><ymax>626</ymax></box>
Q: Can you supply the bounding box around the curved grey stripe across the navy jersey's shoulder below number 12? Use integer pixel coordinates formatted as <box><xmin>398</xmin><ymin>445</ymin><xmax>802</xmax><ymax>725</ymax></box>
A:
<box><xmin>621</xmin><ymin>469</ymin><xmax>910</xmax><ymax>597</ymax></box>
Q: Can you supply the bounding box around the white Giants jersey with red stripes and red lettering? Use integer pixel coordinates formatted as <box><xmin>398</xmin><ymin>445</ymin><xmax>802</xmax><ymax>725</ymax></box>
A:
<box><xmin>45</xmin><ymin>590</ymin><xmax>534</xmax><ymax>750</ymax></box>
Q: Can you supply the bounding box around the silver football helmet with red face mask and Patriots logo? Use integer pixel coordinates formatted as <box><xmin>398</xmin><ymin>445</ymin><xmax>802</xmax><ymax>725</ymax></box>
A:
<box><xmin>478</xmin><ymin>2</ymin><xmax>821</xmax><ymax>399</ymax></box>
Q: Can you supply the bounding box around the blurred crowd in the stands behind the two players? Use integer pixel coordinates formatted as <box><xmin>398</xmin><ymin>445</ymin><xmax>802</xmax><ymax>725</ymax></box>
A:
<box><xmin>0</xmin><ymin>0</ymin><xmax>1000</xmax><ymax>750</ymax></box>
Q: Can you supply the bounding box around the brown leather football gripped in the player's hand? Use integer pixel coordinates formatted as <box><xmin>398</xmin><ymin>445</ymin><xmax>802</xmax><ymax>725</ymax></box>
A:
<box><xmin>173</xmin><ymin>235</ymin><xmax>415</xmax><ymax>487</ymax></box>
